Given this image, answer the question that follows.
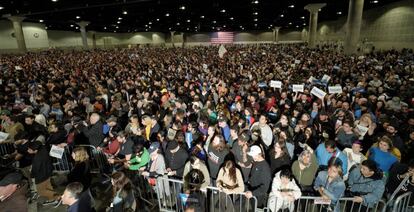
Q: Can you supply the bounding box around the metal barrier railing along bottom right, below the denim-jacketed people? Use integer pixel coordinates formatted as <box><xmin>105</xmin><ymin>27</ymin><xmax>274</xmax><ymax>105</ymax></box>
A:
<box><xmin>264</xmin><ymin>196</ymin><xmax>387</xmax><ymax>212</ymax></box>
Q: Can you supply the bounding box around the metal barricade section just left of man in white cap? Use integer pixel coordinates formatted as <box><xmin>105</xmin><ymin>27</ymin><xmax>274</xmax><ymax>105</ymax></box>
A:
<box><xmin>206</xmin><ymin>187</ymin><xmax>257</xmax><ymax>212</ymax></box>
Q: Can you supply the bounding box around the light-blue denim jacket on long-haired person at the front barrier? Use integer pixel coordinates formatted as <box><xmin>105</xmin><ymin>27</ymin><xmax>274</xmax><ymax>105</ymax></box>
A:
<box><xmin>313</xmin><ymin>171</ymin><xmax>346</xmax><ymax>211</ymax></box>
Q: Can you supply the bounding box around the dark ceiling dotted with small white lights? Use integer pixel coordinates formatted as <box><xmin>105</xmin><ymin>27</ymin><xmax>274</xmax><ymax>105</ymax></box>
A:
<box><xmin>0</xmin><ymin>0</ymin><xmax>402</xmax><ymax>32</ymax></box>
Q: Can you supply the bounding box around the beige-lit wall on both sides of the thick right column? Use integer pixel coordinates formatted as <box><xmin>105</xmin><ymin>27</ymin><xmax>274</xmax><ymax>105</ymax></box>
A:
<box><xmin>318</xmin><ymin>0</ymin><xmax>414</xmax><ymax>49</ymax></box>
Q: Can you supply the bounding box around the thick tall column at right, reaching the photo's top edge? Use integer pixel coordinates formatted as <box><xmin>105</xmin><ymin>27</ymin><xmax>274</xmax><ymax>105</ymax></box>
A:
<box><xmin>344</xmin><ymin>0</ymin><xmax>364</xmax><ymax>54</ymax></box>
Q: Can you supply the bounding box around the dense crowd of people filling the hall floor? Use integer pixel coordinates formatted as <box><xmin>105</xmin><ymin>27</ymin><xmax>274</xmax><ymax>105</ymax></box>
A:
<box><xmin>0</xmin><ymin>44</ymin><xmax>414</xmax><ymax>212</ymax></box>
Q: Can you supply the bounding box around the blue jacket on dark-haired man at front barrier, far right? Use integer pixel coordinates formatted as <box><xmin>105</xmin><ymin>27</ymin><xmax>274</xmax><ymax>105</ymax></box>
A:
<box><xmin>348</xmin><ymin>166</ymin><xmax>385</xmax><ymax>207</ymax></box>
